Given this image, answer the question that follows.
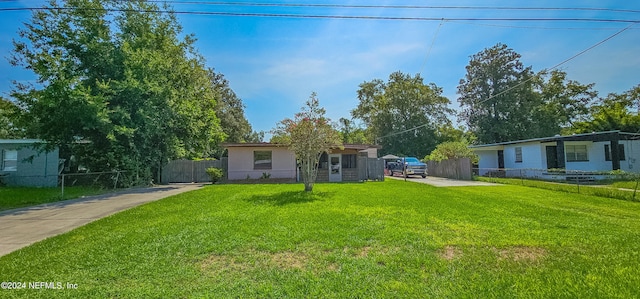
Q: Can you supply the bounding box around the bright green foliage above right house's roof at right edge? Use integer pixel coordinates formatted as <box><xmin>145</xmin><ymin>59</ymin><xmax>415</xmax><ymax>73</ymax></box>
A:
<box><xmin>568</xmin><ymin>85</ymin><xmax>640</xmax><ymax>133</ymax></box>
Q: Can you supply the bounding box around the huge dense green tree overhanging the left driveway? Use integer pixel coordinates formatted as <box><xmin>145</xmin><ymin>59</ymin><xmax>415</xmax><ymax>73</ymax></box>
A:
<box><xmin>12</xmin><ymin>0</ymin><xmax>224</xmax><ymax>182</ymax></box>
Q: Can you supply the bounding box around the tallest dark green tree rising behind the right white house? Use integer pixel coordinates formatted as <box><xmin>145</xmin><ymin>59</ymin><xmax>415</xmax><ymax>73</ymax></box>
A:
<box><xmin>458</xmin><ymin>43</ymin><xmax>541</xmax><ymax>143</ymax></box>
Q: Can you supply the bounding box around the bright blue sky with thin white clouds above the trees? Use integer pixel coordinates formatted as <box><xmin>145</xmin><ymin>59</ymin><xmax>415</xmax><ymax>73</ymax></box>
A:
<box><xmin>0</xmin><ymin>0</ymin><xmax>640</xmax><ymax>137</ymax></box>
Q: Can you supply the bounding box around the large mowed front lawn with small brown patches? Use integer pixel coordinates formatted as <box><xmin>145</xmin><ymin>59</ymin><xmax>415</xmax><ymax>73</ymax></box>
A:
<box><xmin>0</xmin><ymin>180</ymin><xmax>640</xmax><ymax>298</ymax></box>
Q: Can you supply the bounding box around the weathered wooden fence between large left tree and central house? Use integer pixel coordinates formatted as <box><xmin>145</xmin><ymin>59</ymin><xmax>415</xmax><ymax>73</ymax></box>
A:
<box><xmin>162</xmin><ymin>158</ymin><xmax>227</xmax><ymax>184</ymax></box>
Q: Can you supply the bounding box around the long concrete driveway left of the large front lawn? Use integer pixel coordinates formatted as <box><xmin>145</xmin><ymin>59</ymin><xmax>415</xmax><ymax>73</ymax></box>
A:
<box><xmin>0</xmin><ymin>184</ymin><xmax>202</xmax><ymax>256</ymax></box>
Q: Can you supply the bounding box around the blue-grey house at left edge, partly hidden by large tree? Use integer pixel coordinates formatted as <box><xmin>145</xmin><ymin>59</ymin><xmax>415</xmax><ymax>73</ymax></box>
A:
<box><xmin>0</xmin><ymin>139</ymin><xmax>60</xmax><ymax>187</ymax></box>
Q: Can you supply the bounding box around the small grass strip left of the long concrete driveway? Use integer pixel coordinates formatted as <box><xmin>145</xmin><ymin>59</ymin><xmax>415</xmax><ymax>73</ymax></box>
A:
<box><xmin>0</xmin><ymin>187</ymin><xmax>104</xmax><ymax>211</ymax></box>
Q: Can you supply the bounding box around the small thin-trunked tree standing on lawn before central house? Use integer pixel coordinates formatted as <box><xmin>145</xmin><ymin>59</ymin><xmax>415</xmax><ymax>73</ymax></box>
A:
<box><xmin>272</xmin><ymin>92</ymin><xmax>342</xmax><ymax>192</ymax></box>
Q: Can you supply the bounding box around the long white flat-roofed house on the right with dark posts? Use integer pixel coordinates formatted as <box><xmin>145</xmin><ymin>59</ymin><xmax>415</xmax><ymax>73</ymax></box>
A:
<box><xmin>470</xmin><ymin>131</ymin><xmax>640</xmax><ymax>176</ymax></box>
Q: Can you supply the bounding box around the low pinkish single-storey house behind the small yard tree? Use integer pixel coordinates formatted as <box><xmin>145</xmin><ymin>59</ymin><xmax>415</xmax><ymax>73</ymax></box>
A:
<box><xmin>223</xmin><ymin>143</ymin><xmax>384</xmax><ymax>182</ymax></box>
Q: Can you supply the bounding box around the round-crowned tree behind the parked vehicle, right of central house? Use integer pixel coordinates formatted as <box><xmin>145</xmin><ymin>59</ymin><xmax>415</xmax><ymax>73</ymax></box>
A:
<box><xmin>351</xmin><ymin>72</ymin><xmax>453</xmax><ymax>157</ymax></box>
